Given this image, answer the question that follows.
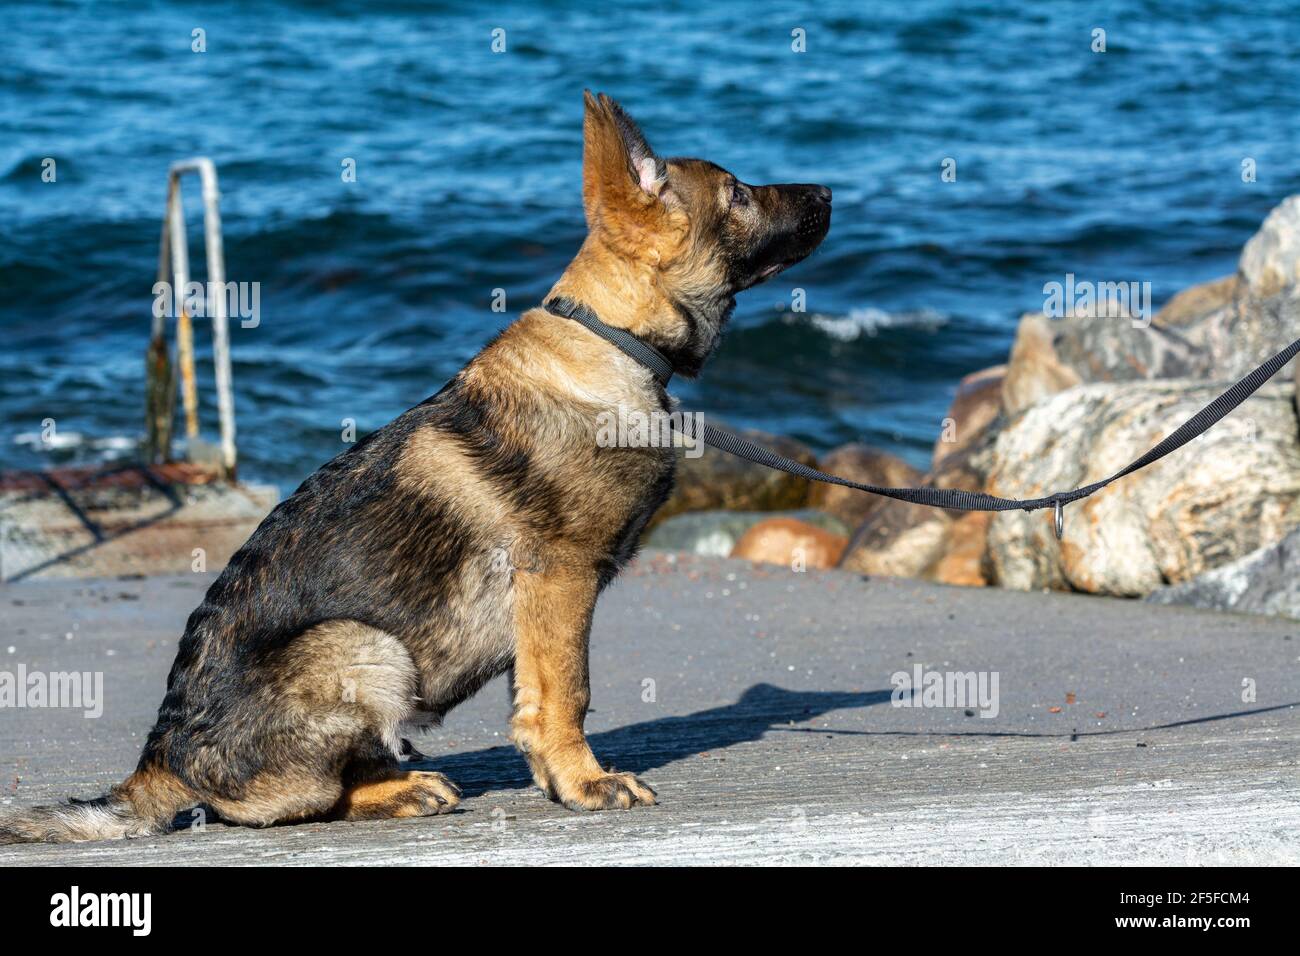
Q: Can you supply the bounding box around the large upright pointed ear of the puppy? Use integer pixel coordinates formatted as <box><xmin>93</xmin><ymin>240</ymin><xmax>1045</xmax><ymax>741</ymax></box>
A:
<box><xmin>582</xmin><ymin>90</ymin><xmax>680</xmax><ymax>260</ymax></box>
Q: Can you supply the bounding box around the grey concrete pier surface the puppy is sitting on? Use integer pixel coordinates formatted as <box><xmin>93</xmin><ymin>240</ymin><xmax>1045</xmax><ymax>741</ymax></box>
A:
<box><xmin>0</xmin><ymin>553</ymin><xmax>1300</xmax><ymax>865</ymax></box>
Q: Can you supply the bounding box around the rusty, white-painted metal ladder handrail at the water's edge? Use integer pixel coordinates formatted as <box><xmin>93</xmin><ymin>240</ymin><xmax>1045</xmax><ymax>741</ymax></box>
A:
<box><xmin>144</xmin><ymin>156</ymin><xmax>237</xmax><ymax>481</ymax></box>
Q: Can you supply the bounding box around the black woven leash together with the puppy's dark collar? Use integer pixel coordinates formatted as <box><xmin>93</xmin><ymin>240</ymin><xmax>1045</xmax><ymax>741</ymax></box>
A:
<box><xmin>543</xmin><ymin>298</ymin><xmax>1300</xmax><ymax>538</ymax></box>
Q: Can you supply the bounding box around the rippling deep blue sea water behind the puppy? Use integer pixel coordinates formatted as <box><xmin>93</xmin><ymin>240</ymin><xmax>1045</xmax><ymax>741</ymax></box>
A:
<box><xmin>0</xmin><ymin>0</ymin><xmax>1300</xmax><ymax>488</ymax></box>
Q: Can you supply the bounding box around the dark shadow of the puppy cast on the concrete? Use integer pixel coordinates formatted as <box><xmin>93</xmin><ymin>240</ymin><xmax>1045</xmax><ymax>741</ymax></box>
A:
<box><xmin>407</xmin><ymin>684</ymin><xmax>893</xmax><ymax>797</ymax></box>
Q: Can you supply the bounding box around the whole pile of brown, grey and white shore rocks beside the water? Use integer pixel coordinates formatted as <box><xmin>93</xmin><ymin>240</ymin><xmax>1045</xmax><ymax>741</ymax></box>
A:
<box><xmin>646</xmin><ymin>195</ymin><xmax>1300</xmax><ymax>619</ymax></box>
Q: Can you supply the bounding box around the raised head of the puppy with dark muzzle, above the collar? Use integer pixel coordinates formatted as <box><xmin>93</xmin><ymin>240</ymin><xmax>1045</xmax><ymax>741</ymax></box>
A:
<box><xmin>582</xmin><ymin>92</ymin><xmax>831</xmax><ymax>376</ymax></box>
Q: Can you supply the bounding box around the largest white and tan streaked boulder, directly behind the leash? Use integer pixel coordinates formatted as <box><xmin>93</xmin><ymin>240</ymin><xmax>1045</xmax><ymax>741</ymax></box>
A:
<box><xmin>988</xmin><ymin>380</ymin><xmax>1300</xmax><ymax>596</ymax></box>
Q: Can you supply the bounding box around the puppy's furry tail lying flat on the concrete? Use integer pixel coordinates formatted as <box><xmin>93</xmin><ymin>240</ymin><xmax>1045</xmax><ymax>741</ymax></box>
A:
<box><xmin>0</xmin><ymin>767</ymin><xmax>199</xmax><ymax>844</ymax></box>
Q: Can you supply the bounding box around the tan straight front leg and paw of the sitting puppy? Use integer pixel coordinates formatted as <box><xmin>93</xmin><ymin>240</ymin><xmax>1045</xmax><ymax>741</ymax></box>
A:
<box><xmin>511</xmin><ymin>568</ymin><xmax>655</xmax><ymax>810</ymax></box>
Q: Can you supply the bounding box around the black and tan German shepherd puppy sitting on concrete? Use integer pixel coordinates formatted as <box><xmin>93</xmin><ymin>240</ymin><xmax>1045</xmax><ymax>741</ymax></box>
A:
<box><xmin>0</xmin><ymin>92</ymin><xmax>831</xmax><ymax>843</ymax></box>
